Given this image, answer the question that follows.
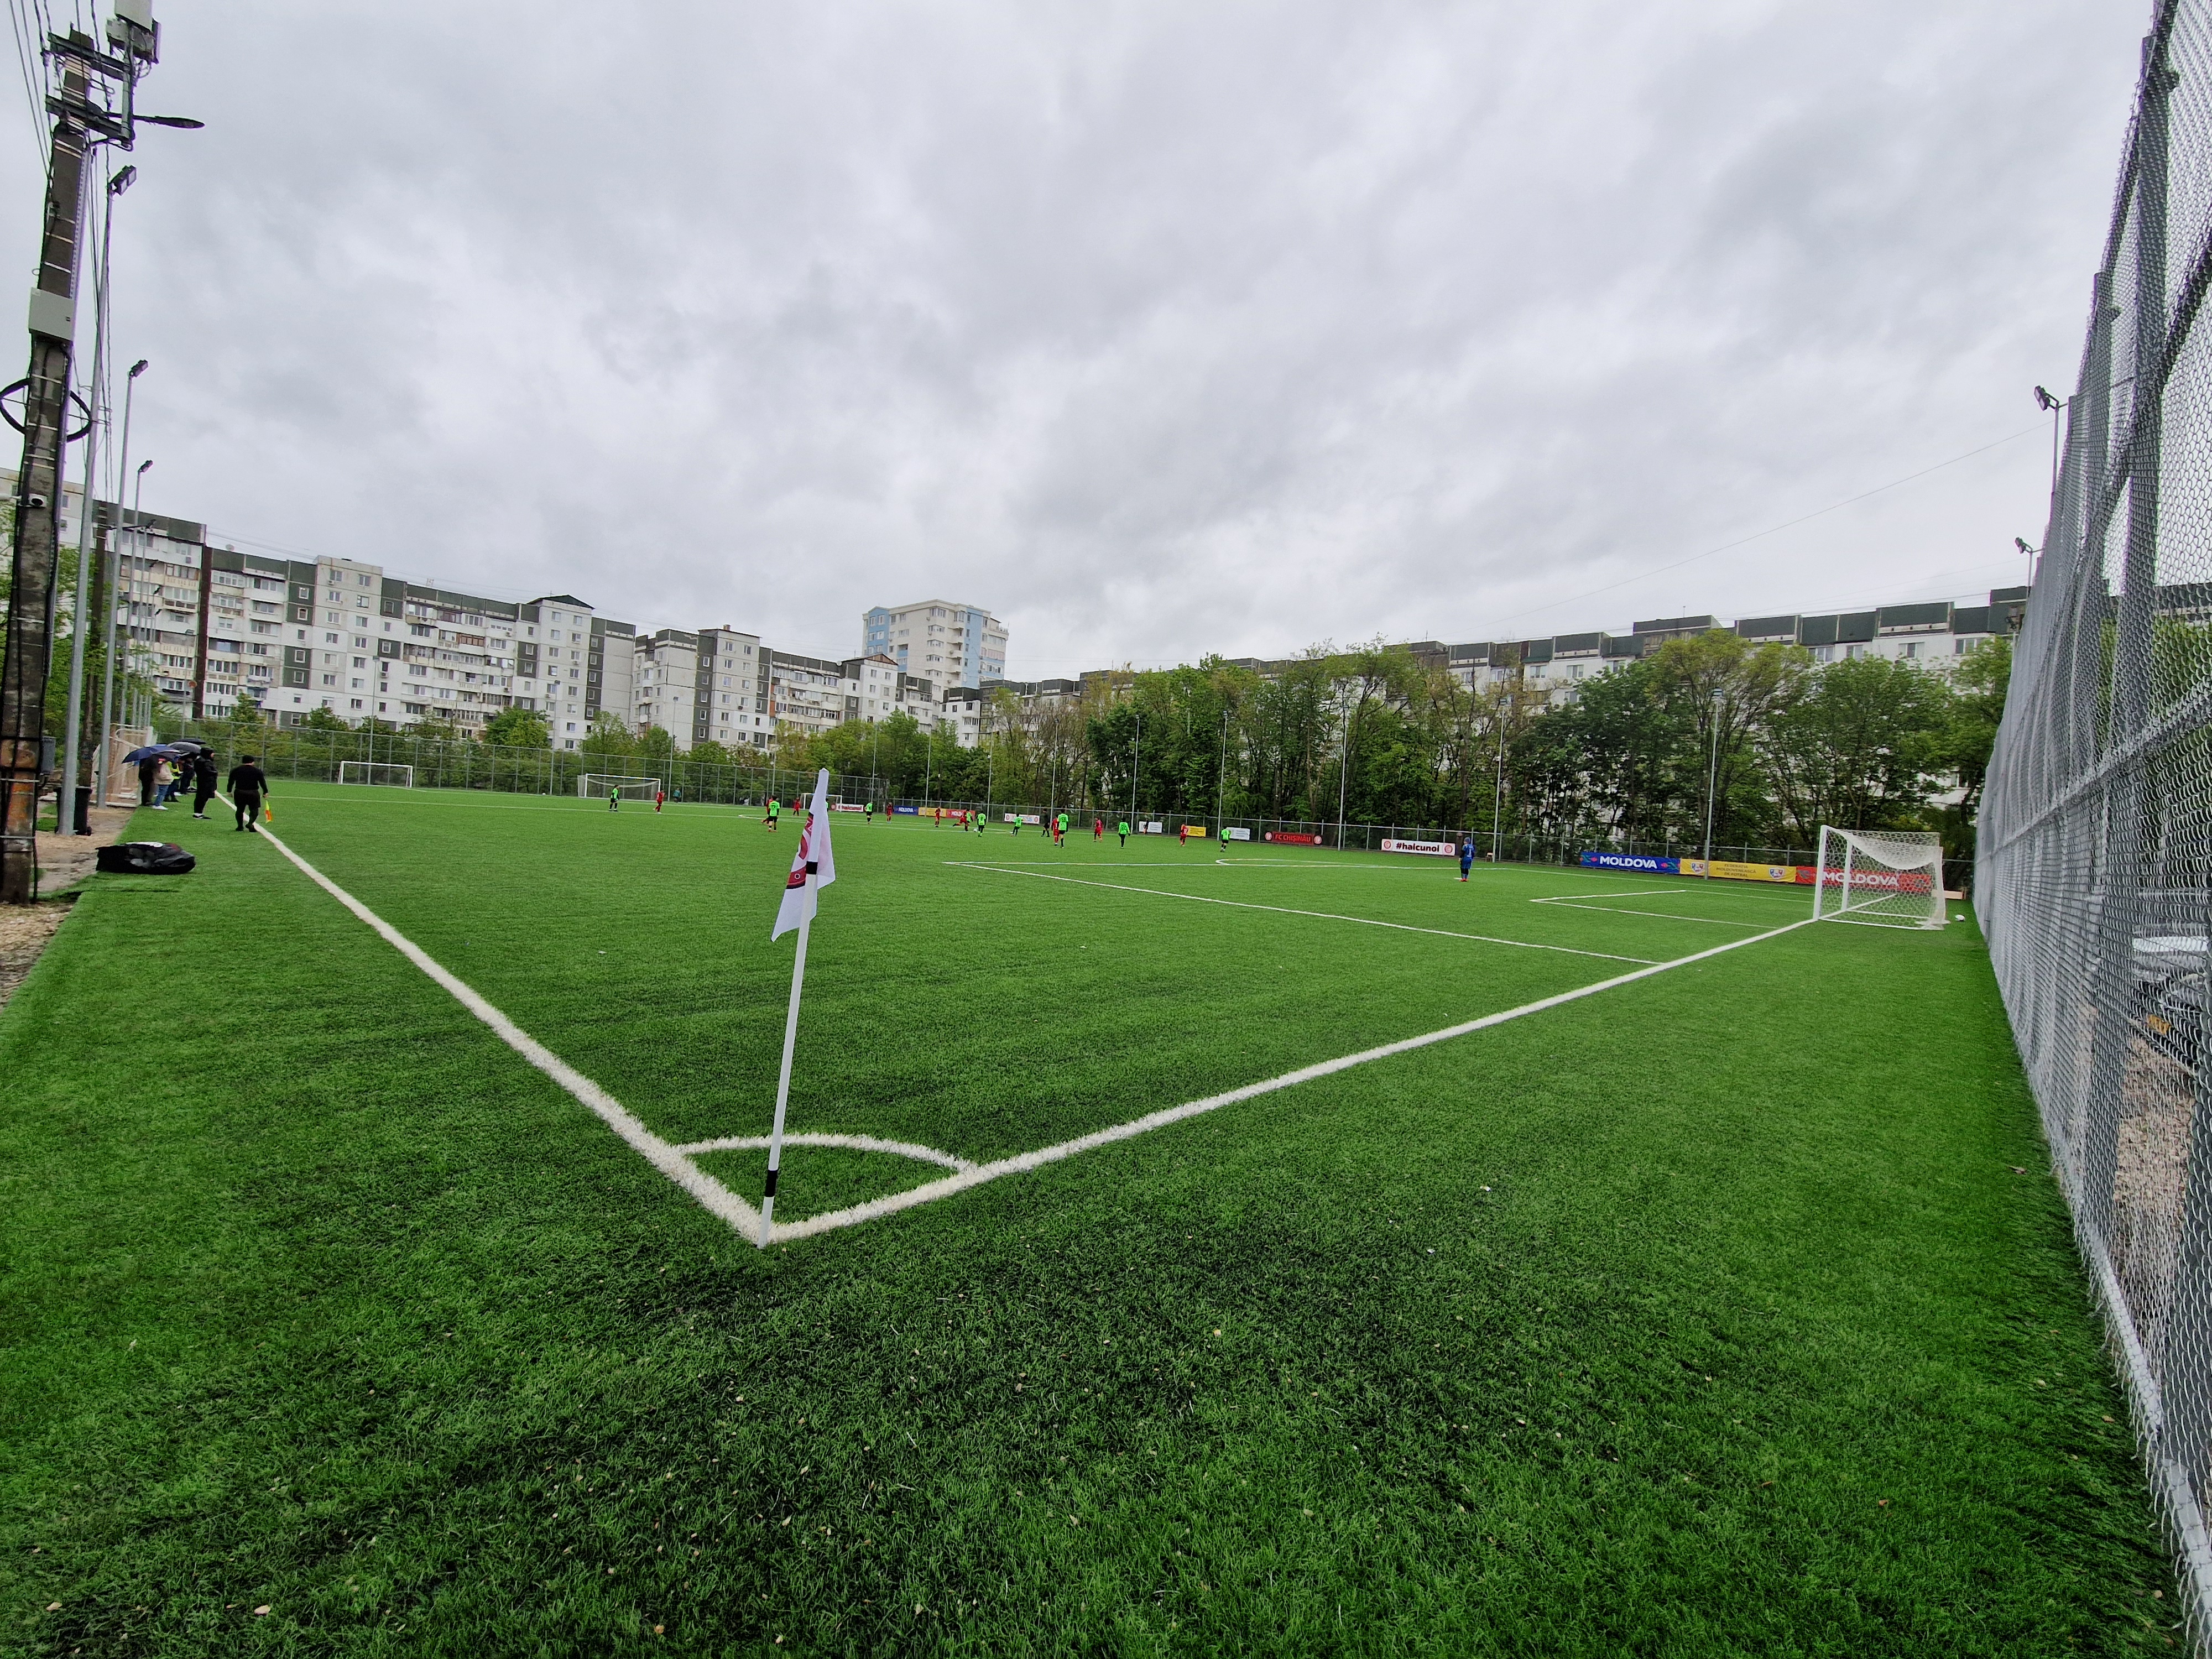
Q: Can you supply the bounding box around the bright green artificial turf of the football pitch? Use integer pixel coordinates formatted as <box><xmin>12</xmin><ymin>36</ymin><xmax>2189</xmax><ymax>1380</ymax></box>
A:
<box><xmin>0</xmin><ymin>783</ymin><xmax>2179</xmax><ymax>1655</ymax></box>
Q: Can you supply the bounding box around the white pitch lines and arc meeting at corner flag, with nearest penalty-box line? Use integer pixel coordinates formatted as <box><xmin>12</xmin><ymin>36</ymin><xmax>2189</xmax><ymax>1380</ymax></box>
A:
<box><xmin>233</xmin><ymin>796</ymin><xmax>1814</xmax><ymax>1243</ymax></box>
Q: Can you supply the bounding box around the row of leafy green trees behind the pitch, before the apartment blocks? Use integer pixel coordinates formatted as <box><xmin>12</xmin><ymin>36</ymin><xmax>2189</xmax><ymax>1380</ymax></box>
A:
<box><xmin>168</xmin><ymin>628</ymin><xmax>2011</xmax><ymax>858</ymax></box>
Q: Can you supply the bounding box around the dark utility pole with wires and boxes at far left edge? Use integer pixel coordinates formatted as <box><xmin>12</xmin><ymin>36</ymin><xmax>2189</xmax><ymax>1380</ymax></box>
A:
<box><xmin>0</xmin><ymin>0</ymin><xmax>157</xmax><ymax>905</ymax></box>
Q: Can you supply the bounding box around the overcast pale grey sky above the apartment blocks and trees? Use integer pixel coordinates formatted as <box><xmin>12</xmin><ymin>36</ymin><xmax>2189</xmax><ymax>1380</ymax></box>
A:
<box><xmin>0</xmin><ymin>0</ymin><xmax>2146</xmax><ymax>679</ymax></box>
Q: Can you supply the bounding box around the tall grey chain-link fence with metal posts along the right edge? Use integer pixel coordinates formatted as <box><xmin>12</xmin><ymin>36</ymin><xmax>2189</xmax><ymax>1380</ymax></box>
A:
<box><xmin>1975</xmin><ymin>0</ymin><xmax>2212</xmax><ymax>1646</ymax></box>
